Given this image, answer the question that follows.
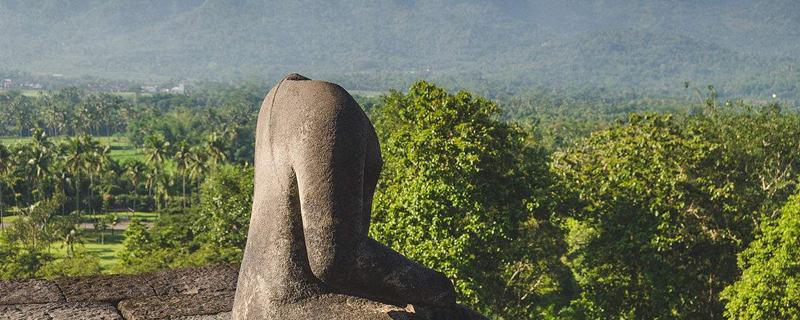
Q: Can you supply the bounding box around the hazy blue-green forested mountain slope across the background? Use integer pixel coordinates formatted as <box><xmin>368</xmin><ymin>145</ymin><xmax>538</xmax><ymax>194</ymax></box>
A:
<box><xmin>0</xmin><ymin>0</ymin><xmax>800</xmax><ymax>98</ymax></box>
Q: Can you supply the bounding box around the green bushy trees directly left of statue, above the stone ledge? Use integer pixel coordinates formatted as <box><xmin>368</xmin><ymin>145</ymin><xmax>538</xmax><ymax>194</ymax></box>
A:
<box><xmin>115</xmin><ymin>165</ymin><xmax>253</xmax><ymax>273</ymax></box>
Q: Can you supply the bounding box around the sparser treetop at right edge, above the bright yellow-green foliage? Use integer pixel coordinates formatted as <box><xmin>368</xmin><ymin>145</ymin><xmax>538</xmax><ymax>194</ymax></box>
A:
<box><xmin>686</xmin><ymin>100</ymin><xmax>800</xmax><ymax>222</ymax></box>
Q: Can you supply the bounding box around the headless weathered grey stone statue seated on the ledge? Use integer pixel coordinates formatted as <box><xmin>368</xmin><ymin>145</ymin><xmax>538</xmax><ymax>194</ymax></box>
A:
<box><xmin>233</xmin><ymin>74</ymin><xmax>480</xmax><ymax>319</ymax></box>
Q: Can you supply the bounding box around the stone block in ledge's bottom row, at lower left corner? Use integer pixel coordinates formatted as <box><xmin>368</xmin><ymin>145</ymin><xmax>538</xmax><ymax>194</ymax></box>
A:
<box><xmin>0</xmin><ymin>302</ymin><xmax>122</xmax><ymax>320</ymax></box>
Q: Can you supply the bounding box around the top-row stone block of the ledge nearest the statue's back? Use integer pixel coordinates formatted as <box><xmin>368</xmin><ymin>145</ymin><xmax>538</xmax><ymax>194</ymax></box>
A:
<box><xmin>148</xmin><ymin>265</ymin><xmax>237</xmax><ymax>295</ymax></box>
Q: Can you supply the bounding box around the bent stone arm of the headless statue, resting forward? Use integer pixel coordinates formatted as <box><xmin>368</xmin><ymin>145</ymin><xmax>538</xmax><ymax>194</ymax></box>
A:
<box><xmin>292</xmin><ymin>101</ymin><xmax>455</xmax><ymax>305</ymax></box>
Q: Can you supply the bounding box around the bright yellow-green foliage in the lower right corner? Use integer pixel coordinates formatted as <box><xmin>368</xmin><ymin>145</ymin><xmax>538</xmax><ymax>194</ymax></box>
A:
<box><xmin>722</xmin><ymin>196</ymin><xmax>800</xmax><ymax>320</ymax></box>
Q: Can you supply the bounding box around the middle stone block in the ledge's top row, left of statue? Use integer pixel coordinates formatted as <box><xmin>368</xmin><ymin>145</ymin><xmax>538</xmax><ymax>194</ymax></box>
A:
<box><xmin>55</xmin><ymin>275</ymin><xmax>155</xmax><ymax>302</ymax></box>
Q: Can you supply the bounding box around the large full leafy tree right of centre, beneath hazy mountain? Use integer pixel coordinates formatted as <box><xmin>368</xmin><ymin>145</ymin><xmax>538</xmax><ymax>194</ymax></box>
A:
<box><xmin>554</xmin><ymin>115</ymin><xmax>736</xmax><ymax>319</ymax></box>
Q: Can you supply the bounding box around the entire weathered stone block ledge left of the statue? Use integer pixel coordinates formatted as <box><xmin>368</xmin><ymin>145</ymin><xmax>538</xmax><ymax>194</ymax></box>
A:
<box><xmin>0</xmin><ymin>265</ymin><xmax>239</xmax><ymax>320</ymax></box>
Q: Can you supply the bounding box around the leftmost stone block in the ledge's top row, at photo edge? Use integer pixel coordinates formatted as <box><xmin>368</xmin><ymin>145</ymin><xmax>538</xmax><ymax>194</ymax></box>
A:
<box><xmin>0</xmin><ymin>279</ymin><xmax>64</xmax><ymax>305</ymax></box>
